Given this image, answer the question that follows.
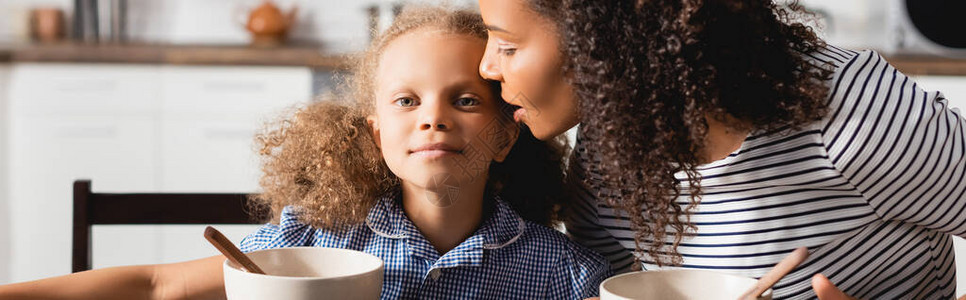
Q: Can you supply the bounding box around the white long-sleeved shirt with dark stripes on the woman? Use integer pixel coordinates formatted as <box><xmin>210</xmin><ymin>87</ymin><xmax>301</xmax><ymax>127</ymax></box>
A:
<box><xmin>568</xmin><ymin>46</ymin><xmax>966</xmax><ymax>299</ymax></box>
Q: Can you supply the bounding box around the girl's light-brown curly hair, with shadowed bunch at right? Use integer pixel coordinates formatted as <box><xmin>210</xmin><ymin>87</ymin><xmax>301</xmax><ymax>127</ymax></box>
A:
<box><xmin>251</xmin><ymin>6</ymin><xmax>567</xmax><ymax>229</ymax></box>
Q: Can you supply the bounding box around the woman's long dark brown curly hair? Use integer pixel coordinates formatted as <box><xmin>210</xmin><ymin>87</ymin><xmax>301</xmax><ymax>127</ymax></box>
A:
<box><xmin>529</xmin><ymin>0</ymin><xmax>831</xmax><ymax>265</ymax></box>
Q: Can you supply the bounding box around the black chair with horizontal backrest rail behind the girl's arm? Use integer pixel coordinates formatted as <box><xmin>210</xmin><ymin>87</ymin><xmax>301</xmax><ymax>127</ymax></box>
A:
<box><xmin>71</xmin><ymin>180</ymin><xmax>264</xmax><ymax>272</ymax></box>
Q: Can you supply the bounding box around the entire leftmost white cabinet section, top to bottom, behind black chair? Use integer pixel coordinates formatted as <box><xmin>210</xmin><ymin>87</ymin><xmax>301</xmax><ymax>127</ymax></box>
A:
<box><xmin>6</xmin><ymin>64</ymin><xmax>158</xmax><ymax>281</ymax></box>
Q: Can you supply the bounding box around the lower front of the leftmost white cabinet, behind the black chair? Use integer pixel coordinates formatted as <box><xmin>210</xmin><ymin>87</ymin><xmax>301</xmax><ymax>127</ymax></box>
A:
<box><xmin>10</xmin><ymin>116</ymin><xmax>158</xmax><ymax>272</ymax></box>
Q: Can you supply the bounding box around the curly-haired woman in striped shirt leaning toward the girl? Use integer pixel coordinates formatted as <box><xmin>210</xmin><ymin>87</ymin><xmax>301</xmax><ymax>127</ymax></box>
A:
<box><xmin>480</xmin><ymin>0</ymin><xmax>966</xmax><ymax>299</ymax></box>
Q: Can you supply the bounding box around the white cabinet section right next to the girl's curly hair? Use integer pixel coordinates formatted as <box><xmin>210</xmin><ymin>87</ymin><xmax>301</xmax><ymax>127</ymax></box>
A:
<box><xmin>160</xmin><ymin>66</ymin><xmax>312</xmax><ymax>192</ymax></box>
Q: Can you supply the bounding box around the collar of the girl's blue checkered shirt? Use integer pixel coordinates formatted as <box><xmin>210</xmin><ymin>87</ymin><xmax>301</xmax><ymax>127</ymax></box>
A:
<box><xmin>366</xmin><ymin>190</ymin><xmax>526</xmax><ymax>252</ymax></box>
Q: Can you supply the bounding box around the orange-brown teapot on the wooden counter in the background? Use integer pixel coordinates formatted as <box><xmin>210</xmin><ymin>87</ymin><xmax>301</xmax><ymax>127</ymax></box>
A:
<box><xmin>244</xmin><ymin>0</ymin><xmax>298</xmax><ymax>46</ymax></box>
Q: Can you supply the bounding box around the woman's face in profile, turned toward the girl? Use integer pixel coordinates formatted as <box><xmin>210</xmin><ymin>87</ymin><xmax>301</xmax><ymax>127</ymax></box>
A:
<box><xmin>480</xmin><ymin>0</ymin><xmax>577</xmax><ymax>140</ymax></box>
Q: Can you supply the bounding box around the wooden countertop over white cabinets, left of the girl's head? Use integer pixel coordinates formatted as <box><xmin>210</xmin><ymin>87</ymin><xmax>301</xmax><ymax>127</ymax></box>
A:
<box><xmin>0</xmin><ymin>43</ymin><xmax>349</xmax><ymax>69</ymax></box>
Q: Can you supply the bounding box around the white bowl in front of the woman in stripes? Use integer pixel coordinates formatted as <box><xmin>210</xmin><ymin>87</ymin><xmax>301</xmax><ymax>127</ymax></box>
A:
<box><xmin>600</xmin><ymin>270</ymin><xmax>771</xmax><ymax>300</ymax></box>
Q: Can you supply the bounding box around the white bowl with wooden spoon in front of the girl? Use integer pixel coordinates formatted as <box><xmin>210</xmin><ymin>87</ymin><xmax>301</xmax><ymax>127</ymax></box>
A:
<box><xmin>224</xmin><ymin>247</ymin><xmax>383</xmax><ymax>300</ymax></box>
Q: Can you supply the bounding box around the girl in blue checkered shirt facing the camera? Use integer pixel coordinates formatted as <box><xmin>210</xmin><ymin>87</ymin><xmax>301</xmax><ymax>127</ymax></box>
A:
<box><xmin>0</xmin><ymin>8</ymin><xmax>609</xmax><ymax>299</ymax></box>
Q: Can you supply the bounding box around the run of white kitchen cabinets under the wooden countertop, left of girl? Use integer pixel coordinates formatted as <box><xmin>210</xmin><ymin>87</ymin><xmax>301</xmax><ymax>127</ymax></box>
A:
<box><xmin>0</xmin><ymin>64</ymin><xmax>311</xmax><ymax>284</ymax></box>
